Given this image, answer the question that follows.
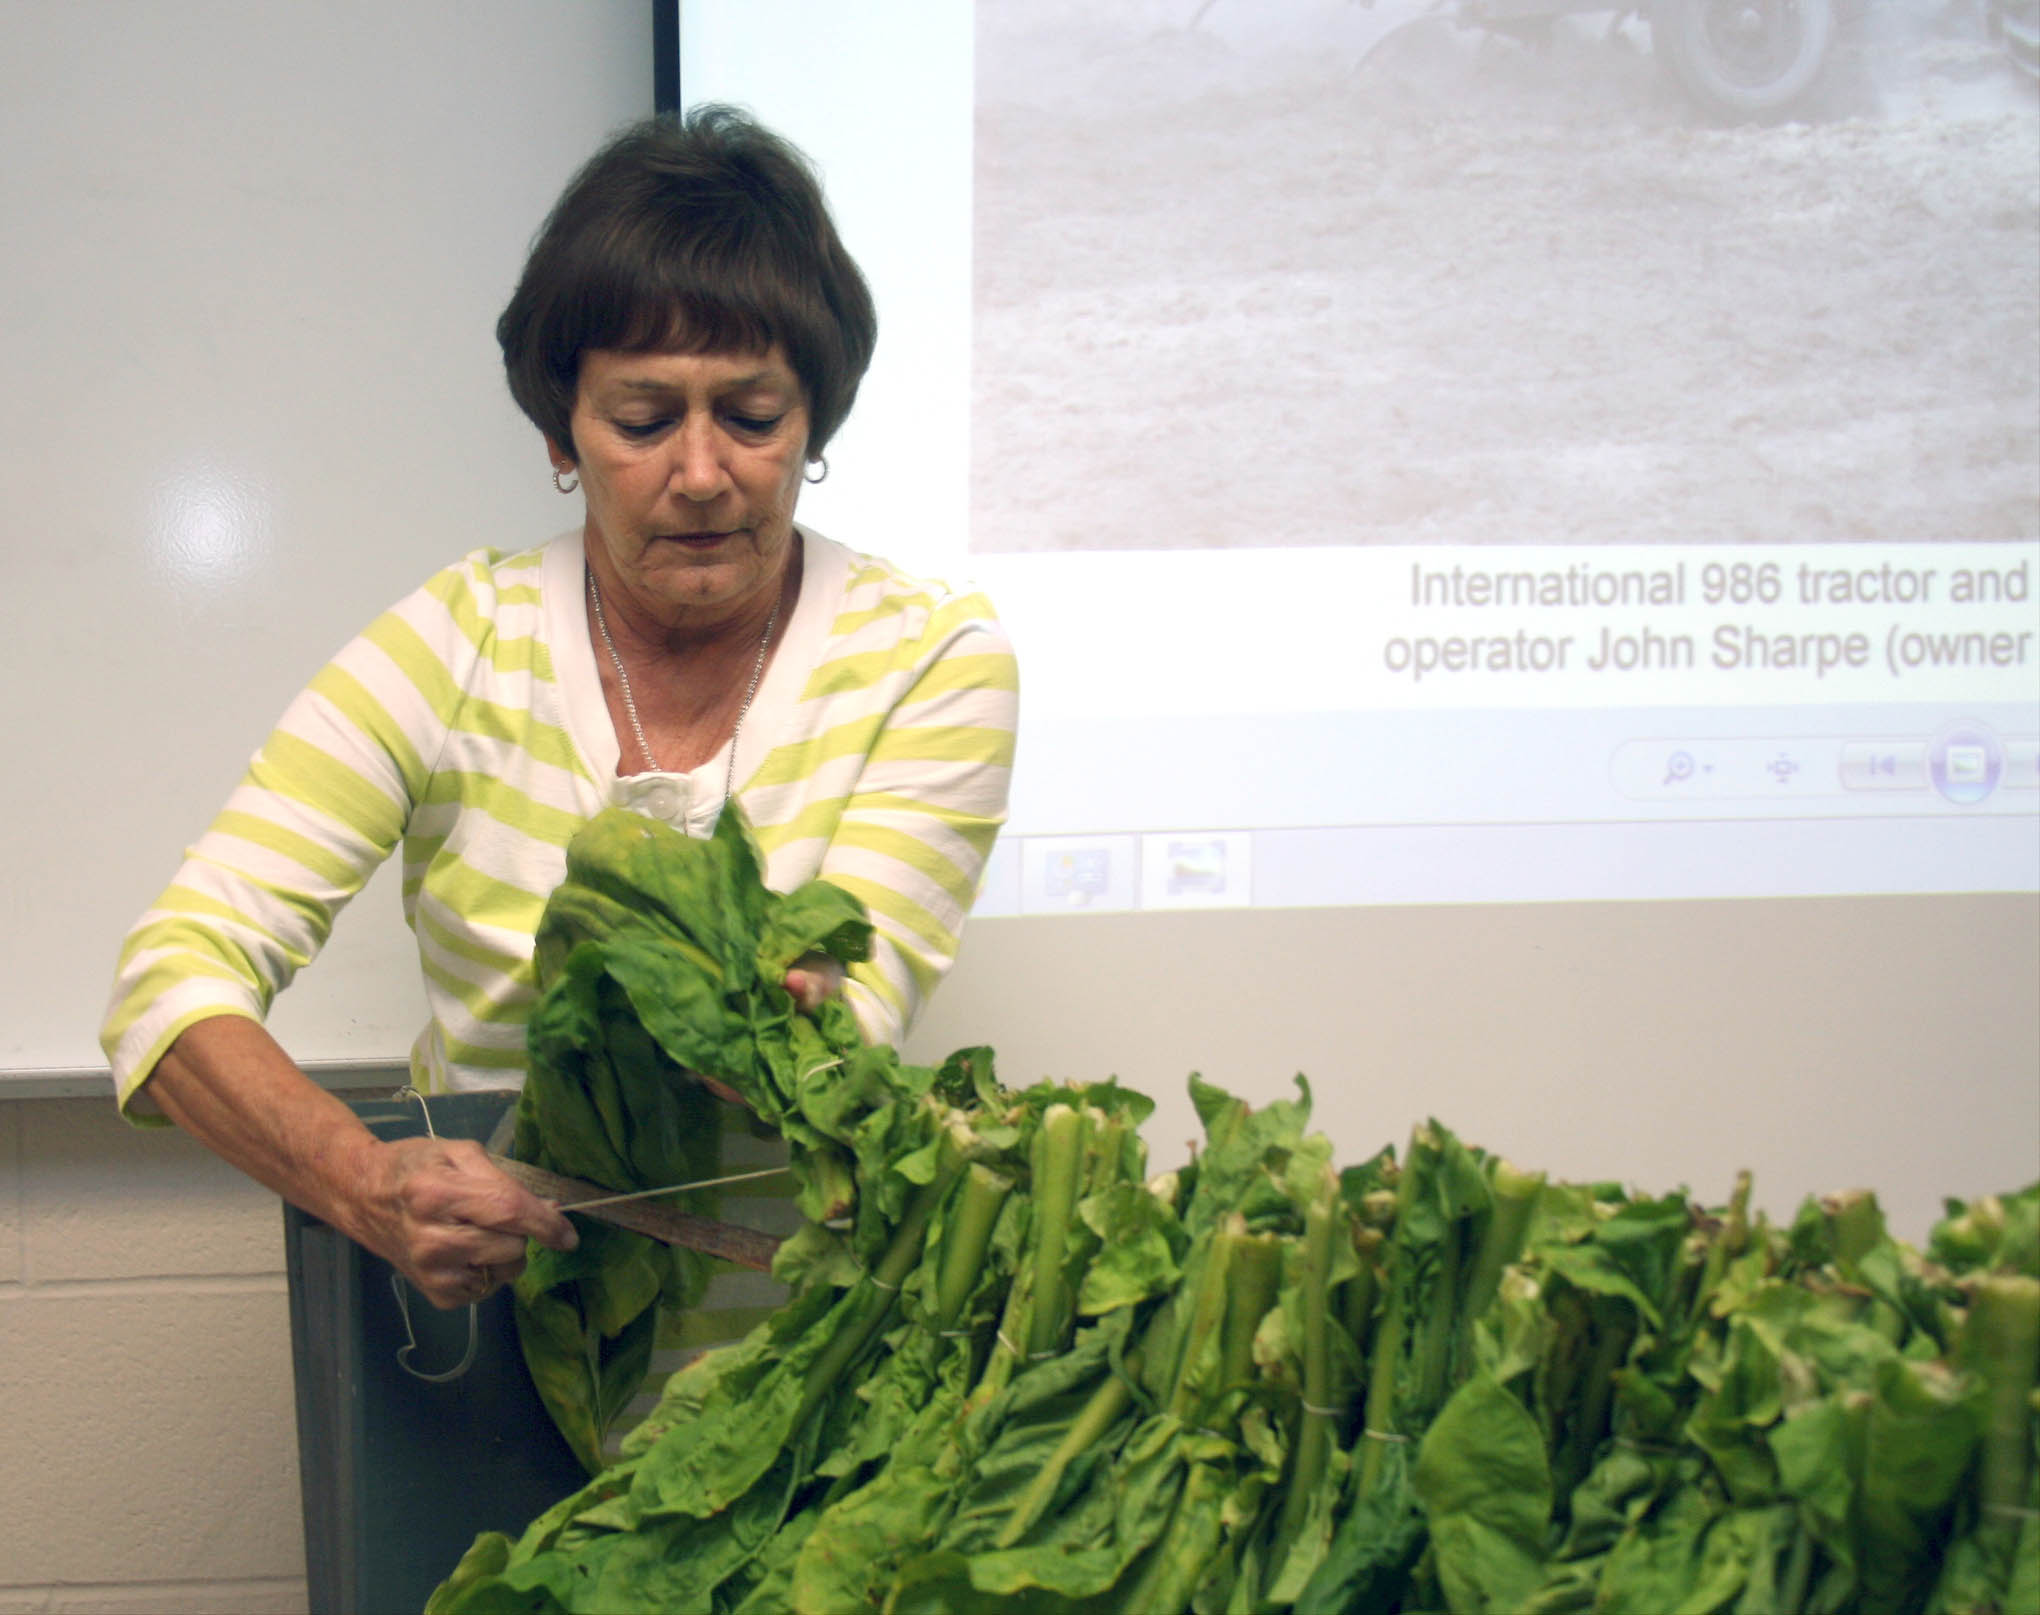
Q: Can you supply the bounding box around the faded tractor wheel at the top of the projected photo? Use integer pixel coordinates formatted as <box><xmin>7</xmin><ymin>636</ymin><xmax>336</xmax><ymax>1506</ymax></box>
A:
<box><xmin>1650</xmin><ymin>0</ymin><xmax>1834</xmax><ymax>122</ymax></box>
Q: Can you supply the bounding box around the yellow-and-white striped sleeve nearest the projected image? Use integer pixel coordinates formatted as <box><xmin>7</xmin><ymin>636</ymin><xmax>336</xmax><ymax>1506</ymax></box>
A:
<box><xmin>820</xmin><ymin>595</ymin><xmax>1020</xmax><ymax>1042</ymax></box>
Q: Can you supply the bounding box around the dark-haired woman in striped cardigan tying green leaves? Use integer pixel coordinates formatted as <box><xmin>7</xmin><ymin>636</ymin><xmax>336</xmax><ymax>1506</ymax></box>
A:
<box><xmin>102</xmin><ymin>108</ymin><xmax>1016</xmax><ymax>1305</ymax></box>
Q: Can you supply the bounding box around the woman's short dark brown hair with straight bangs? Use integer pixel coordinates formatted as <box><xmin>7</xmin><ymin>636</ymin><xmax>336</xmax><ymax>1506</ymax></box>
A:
<box><xmin>496</xmin><ymin>106</ymin><xmax>877</xmax><ymax>459</ymax></box>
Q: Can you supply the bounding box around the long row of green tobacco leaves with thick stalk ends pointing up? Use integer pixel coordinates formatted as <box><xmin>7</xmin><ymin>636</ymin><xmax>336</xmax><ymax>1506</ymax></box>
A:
<box><xmin>428</xmin><ymin>818</ymin><xmax>2040</xmax><ymax>1615</ymax></box>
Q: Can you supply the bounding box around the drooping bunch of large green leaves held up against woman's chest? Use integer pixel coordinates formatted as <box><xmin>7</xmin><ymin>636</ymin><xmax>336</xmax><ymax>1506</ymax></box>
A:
<box><xmin>512</xmin><ymin>810</ymin><xmax>871</xmax><ymax>1472</ymax></box>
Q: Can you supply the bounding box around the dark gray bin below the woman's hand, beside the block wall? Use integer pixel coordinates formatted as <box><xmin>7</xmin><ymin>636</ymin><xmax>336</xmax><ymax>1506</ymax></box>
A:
<box><xmin>284</xmin><ymin>1093</ymin><xmax>585</xmax><ymax>1615</ymax></box>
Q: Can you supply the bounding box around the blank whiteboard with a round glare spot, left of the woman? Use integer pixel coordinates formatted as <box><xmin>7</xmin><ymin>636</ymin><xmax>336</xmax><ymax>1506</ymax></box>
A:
<box><xmin>0</xmin><ymin>0</ymin><xmax>653</xmax><ymax>1085</ymax></box>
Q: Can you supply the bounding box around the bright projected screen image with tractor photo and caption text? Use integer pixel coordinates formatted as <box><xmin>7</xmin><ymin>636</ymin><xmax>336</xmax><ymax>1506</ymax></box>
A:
<box><xmin>681</xmin><ymin>0</ymin><xmax>2040</xmax><ymax>914</ymax></box>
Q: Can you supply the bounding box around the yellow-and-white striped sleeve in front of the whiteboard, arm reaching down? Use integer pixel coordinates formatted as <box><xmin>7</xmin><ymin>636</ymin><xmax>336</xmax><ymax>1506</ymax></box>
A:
<box><xmin>100</xmin><ymin>555</ymin><xmax>490</xmax><ymax>1109</ymax></box>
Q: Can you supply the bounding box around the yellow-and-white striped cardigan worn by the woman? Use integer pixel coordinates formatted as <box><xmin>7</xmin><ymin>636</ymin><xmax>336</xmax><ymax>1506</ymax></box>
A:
<box><xmin>102</xmin><ymin>530</ymin><xmax>1018</xmax><ymax>1107</ymax></box>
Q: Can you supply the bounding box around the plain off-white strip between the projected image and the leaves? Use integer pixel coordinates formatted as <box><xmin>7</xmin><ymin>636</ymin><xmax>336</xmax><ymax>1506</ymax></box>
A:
<box><xmin>912</xmin><ymin>895</ymin><xmax>2040</xmax><ymax>1240</ymax></box>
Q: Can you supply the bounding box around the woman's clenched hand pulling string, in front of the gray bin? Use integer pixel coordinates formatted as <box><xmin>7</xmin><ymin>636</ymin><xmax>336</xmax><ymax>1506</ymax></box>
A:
<box><xmin>357</xmin><ymin>1138</ymin><xmax>579</xmax><ymax>1307</ymax></box>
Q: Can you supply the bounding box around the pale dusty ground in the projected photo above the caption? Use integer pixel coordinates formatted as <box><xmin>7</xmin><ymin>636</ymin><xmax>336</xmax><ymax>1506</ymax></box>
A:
<box><xmin>971</xmin><ymin>0</ymin><xmax>2040</xmax><ymax>551</ymax></box>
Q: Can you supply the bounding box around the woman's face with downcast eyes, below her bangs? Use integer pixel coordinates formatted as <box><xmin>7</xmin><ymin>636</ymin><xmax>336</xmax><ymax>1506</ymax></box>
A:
<box><xmin>555</xmin><ymin>347</ymin><xmax>808</xmax><ymax>630</ymax></box>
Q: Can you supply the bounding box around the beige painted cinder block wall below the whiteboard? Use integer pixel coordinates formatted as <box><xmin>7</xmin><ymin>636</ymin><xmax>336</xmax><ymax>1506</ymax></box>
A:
<box><xmin>0</xmin><ymin>1097</ymin><xmax>371</xmax><ymax>1615</ymax></box>
